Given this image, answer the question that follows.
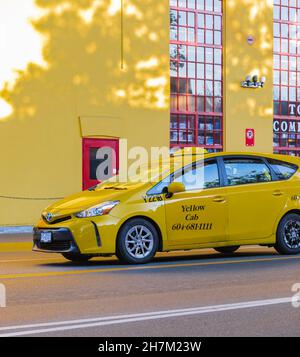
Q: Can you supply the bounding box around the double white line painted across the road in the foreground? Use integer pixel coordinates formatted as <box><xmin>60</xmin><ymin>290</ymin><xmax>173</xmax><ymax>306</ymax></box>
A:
<box><xmin>0</xmin><ymin>297</ymin><xmax>293</xmax><ymax>337</ymax></box>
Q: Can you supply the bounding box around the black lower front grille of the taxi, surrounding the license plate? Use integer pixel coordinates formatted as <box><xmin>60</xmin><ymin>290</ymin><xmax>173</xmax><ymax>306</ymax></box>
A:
<box><xmin>32</xmin><ymin>228</ymin><xmax>80</xmax><ymax>253</ymax></box>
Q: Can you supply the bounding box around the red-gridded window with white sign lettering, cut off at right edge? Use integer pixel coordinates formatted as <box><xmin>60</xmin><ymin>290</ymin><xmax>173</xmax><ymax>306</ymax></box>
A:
<box><xmin>274</xmin><ymin>0</ymin><xmax>300</xmax><ymax>156</ymax></box>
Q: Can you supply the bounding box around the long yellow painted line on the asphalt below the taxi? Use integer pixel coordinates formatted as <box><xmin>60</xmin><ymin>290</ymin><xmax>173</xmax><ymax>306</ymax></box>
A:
<box><xmin>0</xmin><ymin>256</ymin><xmax>300</xmax><ymax>280</ymax></box>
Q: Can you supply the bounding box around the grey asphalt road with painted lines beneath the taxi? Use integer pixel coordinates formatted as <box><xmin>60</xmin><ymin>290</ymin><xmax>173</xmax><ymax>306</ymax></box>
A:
<box><xmin>0</xmin><ymin>241</ymin><xmax>300</xmax><ymax>337</ymax></box>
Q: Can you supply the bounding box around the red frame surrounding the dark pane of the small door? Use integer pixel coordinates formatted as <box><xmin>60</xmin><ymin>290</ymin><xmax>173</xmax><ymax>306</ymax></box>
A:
<box><xmin>82</xmin><ymin>138</ymin><xmax>119</xmax><ymax>190</ymax></box>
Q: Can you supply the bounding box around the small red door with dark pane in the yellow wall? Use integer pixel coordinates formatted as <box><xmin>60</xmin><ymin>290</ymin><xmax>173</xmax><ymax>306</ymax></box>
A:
<box><xmin>83</xmin><ymin>139</ymin><xmax>119</xmax><ymax>190</ymax></box>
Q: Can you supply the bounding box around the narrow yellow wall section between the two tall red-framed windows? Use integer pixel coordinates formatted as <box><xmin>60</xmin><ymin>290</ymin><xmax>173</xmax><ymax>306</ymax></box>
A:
<box><xmin>224</xmin><ymin>0</ymin><xmax>273</xmax><ymax>152</ymax></box>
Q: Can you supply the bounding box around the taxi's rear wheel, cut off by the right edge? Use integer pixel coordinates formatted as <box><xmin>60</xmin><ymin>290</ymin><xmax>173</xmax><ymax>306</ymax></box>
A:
<box><xmin>274</xmin><ymin>213</ymin><xmax>300</xmax><ymax>255</ymax></box>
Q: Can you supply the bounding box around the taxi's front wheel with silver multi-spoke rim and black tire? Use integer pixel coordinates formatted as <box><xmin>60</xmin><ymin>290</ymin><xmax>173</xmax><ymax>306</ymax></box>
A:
<box><xmin>116</xmin><ymin>218</ymin><xmax>159</xmax><ymax>264</ymax></box>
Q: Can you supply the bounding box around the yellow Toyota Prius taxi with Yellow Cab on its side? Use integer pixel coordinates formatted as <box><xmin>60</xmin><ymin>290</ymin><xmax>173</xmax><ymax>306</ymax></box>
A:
<box><xmin>33</xmin><ymin>153</ymin><xmax>300</xmax><ymax>264</ymax></box>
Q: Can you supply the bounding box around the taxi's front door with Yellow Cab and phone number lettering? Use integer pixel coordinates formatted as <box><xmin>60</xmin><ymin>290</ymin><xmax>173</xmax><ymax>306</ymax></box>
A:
<box><xmin>165</xmin><ymin>160</ymin><xmax>227</xmax><ymax>245</ymax></box>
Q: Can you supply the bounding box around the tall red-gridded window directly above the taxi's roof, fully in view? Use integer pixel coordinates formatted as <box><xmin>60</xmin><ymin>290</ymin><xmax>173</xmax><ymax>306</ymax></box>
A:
<box><xmin>170</xmin><ymin>0</ymin><xmax>223</xmax><ymax>151</ymax></box>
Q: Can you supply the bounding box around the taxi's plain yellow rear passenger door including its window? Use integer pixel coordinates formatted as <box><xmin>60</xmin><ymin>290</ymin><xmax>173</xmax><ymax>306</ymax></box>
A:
<box><xmin>223</xmin><ymin>156</ymin><xmax>286</xmax><ymax>241</ymax></box>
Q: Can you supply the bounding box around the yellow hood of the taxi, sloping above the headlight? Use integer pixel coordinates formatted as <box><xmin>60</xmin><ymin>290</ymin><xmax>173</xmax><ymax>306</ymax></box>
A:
<box><xmin>43</xmin><ymin>183</ymin><xmax>147</xmax><ymax>217</ymax></box>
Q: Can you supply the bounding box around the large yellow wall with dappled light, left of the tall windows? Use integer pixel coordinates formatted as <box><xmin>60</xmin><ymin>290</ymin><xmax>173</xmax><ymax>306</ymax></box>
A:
<box><xmin>0</xmin><ymin>0</ymin><xmax>170</xmax><ymax>225</ymax></box>
